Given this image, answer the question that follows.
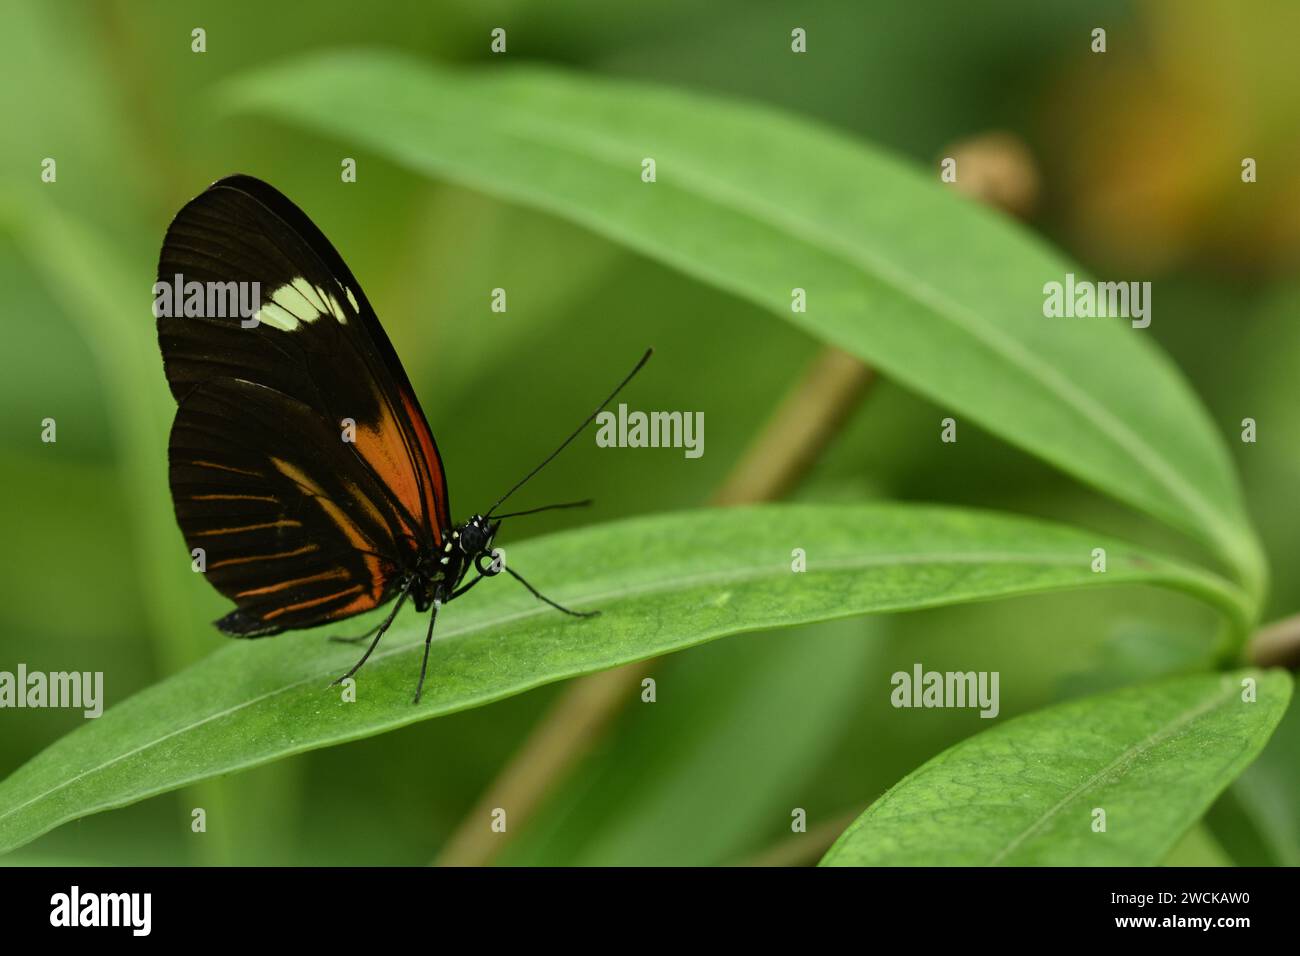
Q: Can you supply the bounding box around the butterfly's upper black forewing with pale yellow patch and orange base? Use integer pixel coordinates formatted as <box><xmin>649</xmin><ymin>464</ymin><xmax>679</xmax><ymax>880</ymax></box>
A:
<box><xmin>159</xmin><ymin>176</ymin><xmax>450</xmax><ymax>548</ymax></box>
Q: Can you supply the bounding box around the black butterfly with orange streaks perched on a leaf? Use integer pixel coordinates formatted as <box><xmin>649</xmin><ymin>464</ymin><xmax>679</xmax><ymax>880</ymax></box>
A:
<box><xmin>153</xmin><ymin>176</ymin><xmax>651</xmax><ymax>702</ymax></box>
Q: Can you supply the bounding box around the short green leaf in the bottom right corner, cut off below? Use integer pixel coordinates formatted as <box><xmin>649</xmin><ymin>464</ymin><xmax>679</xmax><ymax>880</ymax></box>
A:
<box><xmin>822</xmin><ymin>670</ymin><xmax>1291</xmax><ymax>866</ymax></box>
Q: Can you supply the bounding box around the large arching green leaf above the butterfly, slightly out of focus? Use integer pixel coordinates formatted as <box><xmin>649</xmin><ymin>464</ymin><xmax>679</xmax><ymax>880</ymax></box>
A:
<box><xmin>225</xmin><ymin>53</ymin><xmax>1265</xmax><ymax>593</ymax></box>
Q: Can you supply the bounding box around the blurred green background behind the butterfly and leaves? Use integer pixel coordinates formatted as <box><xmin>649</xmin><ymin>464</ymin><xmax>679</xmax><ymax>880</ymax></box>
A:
<box><xmin>0</xmin><ymin>0</ymin><xmax>1300</xmax><ymax>865</ymax></box>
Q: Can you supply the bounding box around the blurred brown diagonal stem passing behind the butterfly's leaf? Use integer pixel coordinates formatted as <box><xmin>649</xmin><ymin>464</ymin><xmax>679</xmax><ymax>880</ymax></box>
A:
<box><xmin>434</xmin><ymin>347</ymin><xmax>874</xmax><ymax>866</ymax></box>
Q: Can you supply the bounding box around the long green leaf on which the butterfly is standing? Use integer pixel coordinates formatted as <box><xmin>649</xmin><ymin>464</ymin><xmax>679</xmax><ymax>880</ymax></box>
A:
<box><xmin>0</xmin><ymin>505</ymin><xmax>1247</xmax><ymax>852</ymax></box>
